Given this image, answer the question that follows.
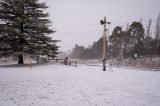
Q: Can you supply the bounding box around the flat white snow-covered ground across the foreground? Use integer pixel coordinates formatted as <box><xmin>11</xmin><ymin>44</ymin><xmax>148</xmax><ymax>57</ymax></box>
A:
<box><xmin>0</xmin><ymin>64</ymin><xmax>160</xmax><ymax>106</ymax></box>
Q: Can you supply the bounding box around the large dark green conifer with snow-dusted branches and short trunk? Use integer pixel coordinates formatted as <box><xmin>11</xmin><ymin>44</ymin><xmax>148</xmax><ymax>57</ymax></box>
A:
<box><xmin>0</xmin><ymin>0</ymin><xmax>58</xmax><ymax>64</ymax></box>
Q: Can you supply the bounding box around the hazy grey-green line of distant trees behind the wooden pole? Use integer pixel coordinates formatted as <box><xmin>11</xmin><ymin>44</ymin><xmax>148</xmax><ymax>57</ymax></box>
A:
<box><xmin>71</xmin><ymin>14</ymin><xmax>160</xmax><ymax>60</ymax></box>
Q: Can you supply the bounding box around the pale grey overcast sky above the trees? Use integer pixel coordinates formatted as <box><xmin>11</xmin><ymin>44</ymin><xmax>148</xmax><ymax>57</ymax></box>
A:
<box><xmin>40</xmin><ymin>0</ymin><xmax>160</xmax><ymax>51</ymax></box>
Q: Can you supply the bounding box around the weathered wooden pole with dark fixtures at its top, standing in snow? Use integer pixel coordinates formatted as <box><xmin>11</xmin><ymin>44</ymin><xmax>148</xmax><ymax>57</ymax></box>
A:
<box><xmin>100</xmin><ymin>17</ymin><xmax>110</xmax><ymax>71</ymax></box>
